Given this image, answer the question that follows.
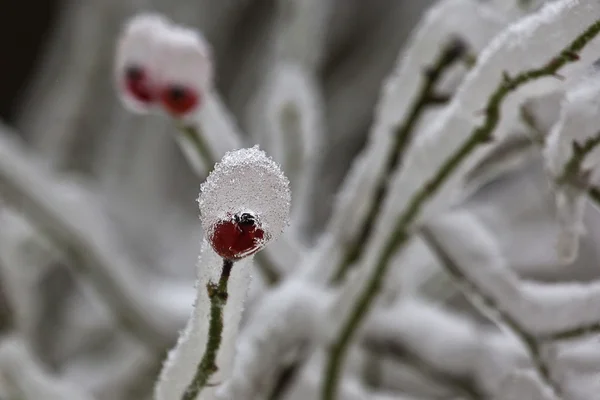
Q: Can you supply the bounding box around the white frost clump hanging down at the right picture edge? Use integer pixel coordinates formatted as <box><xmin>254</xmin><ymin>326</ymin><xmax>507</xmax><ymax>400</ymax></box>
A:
<box><xmin>544</xmin><ymin>75</ymin><xmax>600</xmax><ymax>263</ymax></box>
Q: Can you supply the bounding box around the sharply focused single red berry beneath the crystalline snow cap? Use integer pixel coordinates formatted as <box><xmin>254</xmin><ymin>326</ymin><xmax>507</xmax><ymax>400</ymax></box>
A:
<box><xmin>210</xmin><ymin>213</ymin><xmax>265</xmax><ymax>260</ymax></box>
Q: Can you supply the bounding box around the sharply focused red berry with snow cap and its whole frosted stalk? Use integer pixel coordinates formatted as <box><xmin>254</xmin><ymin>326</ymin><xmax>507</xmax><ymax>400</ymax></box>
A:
<box><xmin>155</xmin><ymin>146</ymin><xmax>291</xmax><ymax>400</ymax></box>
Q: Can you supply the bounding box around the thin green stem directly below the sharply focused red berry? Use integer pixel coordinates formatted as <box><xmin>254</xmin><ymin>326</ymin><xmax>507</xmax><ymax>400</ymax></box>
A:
<box><xmin>181</xmin><ymin>259</ymin><xmax>233</xmax><ymax>400</ymax></box>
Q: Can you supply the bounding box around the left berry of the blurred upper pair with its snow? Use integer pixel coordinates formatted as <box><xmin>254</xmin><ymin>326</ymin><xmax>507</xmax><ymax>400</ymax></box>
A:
<box><xmin>115</xmin><ymin>13</ymin><xmax>170</xmax><ymax>113</ymax></box>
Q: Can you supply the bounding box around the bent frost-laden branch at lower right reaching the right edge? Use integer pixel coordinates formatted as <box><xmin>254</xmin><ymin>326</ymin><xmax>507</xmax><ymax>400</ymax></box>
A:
<box><xmin>424</xmin><ymin>211</ymin><xmax>600</xmax><ymax>395</ymax></box>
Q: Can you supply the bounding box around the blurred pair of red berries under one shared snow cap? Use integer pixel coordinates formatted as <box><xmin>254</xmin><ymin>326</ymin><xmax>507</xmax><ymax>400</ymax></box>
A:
<box><xmin>115</xmin><ymin>14</ymin><xmax>213</xmax><ymax>118</ymax></box>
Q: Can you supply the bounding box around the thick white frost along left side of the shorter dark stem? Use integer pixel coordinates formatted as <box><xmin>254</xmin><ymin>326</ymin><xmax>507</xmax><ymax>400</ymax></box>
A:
<box><xmin>308</xmin><ymin>0</ymin><xmax>506</xmax><ymax>282</ymax></box>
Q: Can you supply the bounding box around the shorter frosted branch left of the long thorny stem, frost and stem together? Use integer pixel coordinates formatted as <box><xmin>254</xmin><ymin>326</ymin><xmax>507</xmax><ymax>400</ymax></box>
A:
<box><xmin>300</xmin><ymin>0</ymin><xmax>506</xmax><ymax>281</ymax></box>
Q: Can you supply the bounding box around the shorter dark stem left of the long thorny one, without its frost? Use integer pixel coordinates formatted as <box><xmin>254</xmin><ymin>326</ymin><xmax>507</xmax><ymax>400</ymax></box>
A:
<box><xmin>332</xmin><ymin>38</ymin><xmax>467</xmax><ymax>283</ymax></box>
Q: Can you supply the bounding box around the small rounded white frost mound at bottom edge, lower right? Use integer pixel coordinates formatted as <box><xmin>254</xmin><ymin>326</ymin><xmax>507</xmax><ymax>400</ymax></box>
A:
<box><xmin>494</xmin><ymin>371</ymin><xmax>558</xmax><ymax>400</ymax></box>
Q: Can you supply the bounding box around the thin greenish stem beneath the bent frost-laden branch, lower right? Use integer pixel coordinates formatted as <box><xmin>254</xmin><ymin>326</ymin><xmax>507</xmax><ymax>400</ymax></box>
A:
<box><xmin>420</xmin><ymin>227</ymin><xmax>561</xmax><ymax>394</ymax></box>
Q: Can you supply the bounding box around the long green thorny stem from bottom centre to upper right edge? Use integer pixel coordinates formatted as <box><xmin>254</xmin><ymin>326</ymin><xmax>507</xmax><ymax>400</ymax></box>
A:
<box><xmin>321</xmin><ymin>20</ymin><xmax>600</xmax><ymax>400</ymax></box>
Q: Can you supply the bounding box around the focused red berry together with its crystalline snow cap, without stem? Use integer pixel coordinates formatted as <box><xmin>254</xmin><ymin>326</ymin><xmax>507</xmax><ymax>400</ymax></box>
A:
<box><xmin>198</xmin><ymin>146</ymin><xmax>291</xmax><ymax>259</ymax></box>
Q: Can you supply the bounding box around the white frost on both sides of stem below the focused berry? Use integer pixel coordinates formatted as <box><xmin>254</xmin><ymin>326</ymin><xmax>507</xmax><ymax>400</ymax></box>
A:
<box><xmin>154</xmin><ymin>240</ymin><xmax>252</xmax><ymax>400</ymax></box>
